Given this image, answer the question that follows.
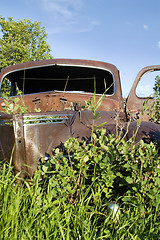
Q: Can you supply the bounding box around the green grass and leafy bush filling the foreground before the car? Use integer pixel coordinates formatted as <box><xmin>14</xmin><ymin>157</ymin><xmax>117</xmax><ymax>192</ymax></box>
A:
<box><xmin>0</xmin><ymin>131</ymin><xmax>160</xmax><ymax>240</ymax></box>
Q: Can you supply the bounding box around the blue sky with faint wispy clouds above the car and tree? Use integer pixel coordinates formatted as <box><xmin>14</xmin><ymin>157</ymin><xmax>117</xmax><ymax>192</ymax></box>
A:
<box><xmin>0</xmin><ymin>0</ymin><xmax>160</xmax><ymax>97</ymax></box>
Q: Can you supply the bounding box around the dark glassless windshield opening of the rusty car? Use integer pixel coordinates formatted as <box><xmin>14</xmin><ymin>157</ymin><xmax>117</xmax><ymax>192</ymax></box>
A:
<box><xmin>3</xmin><ymin>65</ymin><xmax>114</xmax><ymax>96</ymax></box>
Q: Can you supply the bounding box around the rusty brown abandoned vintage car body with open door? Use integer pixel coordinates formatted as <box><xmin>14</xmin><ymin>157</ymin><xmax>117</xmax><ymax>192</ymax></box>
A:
<box><xmin>0</xmin><ymin>59</ymin><xmax>160</xmax><ymax>177</ymax></box>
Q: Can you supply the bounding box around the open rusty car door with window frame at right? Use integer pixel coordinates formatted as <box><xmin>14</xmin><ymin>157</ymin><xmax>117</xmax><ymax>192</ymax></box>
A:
<box><xmin>126</xmin><ymin>65</ymin><xmax>160</xmax><ymax>121</ymax></box>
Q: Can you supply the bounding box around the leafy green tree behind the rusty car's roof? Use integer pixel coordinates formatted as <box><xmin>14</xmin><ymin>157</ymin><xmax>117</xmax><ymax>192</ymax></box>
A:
<box><xmin>0</xmin><ymin>17</ymin><xmax>52</xmax><ymax>70</ymax></box>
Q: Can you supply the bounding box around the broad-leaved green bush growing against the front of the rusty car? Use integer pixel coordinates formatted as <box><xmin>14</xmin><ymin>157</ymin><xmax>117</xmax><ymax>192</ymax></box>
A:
<box><xmin>39</xmin><ymin>129</ymin><xmax>160</xmax><ymax>204</ymax></box>
